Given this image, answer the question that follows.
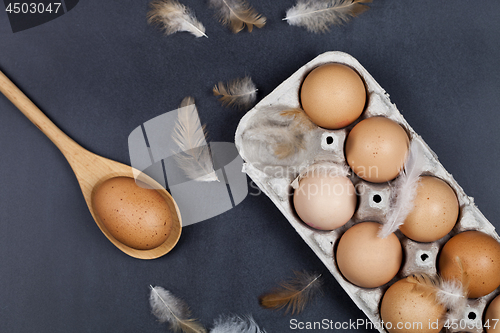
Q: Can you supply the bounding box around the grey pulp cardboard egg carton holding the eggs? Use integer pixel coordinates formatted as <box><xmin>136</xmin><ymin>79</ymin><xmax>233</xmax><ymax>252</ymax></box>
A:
<box><xmin>235</xmin><ymin>52</ymin><xmax>500</xmax><ymax>333</ymax></box>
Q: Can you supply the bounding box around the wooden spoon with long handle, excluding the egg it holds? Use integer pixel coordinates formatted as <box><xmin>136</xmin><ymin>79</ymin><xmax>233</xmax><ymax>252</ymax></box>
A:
<box><xmin>0</xmin><ymin>71</ymin><xmax>182</xmax><ymax>259</ymax></box>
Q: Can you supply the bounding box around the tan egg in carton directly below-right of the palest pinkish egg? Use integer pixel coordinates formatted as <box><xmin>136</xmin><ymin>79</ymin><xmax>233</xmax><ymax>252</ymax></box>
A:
<box><xmin>336</xmin><ymin>222</ymin><xmax>403</xmax><ymax>288</ymax></box>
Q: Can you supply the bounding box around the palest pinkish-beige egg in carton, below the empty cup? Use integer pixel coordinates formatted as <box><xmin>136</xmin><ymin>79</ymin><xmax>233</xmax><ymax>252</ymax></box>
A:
<box><xmin>293</xmin><ymin>175</ymin><xmax>357</xmax><ymax>230</ymax></box>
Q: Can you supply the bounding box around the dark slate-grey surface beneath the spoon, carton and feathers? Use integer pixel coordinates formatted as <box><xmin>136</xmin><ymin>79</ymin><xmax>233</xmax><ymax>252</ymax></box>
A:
<box><xmin>0</xmin><ymin>0</ymin><xmax>500</xmax><ymax>332</ymax></box>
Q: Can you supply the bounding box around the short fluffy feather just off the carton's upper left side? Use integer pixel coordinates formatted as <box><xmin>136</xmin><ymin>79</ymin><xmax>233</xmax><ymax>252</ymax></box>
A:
<box><xmin>213</xmin><ymin>76</ymin><xmax>257</xmax><ymax>109</ymax></box>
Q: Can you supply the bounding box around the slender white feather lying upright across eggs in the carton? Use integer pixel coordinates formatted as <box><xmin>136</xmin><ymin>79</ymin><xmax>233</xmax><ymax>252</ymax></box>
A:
<box><xmin>378</xmin><ymin>140</ymin><xmax>426</xmax><ymax>238</ymax></box>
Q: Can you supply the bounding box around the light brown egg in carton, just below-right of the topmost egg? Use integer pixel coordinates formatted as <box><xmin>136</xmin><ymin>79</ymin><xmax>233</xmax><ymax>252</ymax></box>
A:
<box><xmin>345</xmin><ymin>117</ymin><xmax>409</xmax><ymax>183</ymax></box>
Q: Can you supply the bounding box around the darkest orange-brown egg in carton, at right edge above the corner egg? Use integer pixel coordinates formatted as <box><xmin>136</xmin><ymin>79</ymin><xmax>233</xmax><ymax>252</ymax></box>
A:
<box><xmin>439</xmin><ymin>231</ymin><xmax>500</xmax><ymax>298</ymax></box>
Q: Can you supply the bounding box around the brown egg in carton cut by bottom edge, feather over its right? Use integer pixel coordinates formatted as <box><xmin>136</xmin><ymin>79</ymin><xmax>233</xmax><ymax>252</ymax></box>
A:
<box><xmin>380</xmin><ymin>279</ymin><xmax>446</xmax><ymax>333</ymax></box>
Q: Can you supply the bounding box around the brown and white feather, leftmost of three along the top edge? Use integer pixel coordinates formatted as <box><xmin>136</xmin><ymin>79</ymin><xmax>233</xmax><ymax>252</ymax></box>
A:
<box><xmin>148</xmin><ymin>0</ymin><xmax>208</xmax><ymax>37</ymax></box>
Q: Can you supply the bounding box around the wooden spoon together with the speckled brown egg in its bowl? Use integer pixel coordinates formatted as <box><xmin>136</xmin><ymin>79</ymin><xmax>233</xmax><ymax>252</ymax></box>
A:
<box><xmin>0</xmin><ymin>71</ymin><xmax>182</xmax><ymax>259</ymax></box>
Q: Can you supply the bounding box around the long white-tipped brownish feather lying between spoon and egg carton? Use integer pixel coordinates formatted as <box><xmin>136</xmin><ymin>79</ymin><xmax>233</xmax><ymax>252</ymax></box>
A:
<box><xmin>172</xmin><ymin>97</ymin><xmax>219</xmax><ymax>182</ymax></box>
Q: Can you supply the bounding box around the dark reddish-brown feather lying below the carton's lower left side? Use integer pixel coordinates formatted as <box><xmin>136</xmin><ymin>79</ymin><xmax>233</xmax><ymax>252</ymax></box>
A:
<box><xmin>259</xmin><ymin>272</ymin><xmax>321</xmax><ymax>314</ymax></box>
